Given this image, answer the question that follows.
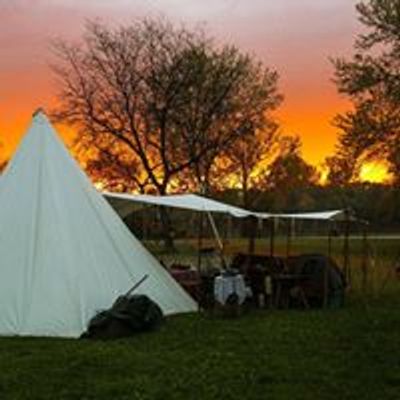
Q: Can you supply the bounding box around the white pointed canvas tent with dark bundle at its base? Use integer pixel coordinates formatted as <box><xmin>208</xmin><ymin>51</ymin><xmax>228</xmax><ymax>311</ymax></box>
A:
<box><xmin>0</xmin><ymin>113</ymin><xmax>196</xmax><ymax>337</ymax></box>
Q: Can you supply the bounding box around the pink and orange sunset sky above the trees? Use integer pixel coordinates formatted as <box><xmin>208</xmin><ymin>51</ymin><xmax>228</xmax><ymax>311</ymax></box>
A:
<box><xmin>0</xmin><ymin>0</ymin><xmax>360</xmax><ymax>169</ymax></box>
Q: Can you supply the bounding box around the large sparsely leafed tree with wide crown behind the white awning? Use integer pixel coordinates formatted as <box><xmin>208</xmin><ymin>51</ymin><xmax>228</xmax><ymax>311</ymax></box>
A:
<box><xmin>53</xmin><ymin>19</ymin><xmax>281</xmax><ymax>247</ymax></box>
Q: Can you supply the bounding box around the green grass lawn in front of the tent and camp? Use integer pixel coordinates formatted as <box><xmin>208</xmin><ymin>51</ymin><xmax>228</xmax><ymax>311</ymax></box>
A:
<box><xmin>0</xmin><ymin>236</ymin><xmax>400</xmax><ymax>400</ymax></box>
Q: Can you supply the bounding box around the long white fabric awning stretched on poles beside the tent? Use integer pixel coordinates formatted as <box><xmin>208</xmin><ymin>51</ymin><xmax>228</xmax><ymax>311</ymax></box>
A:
<box><xmin>103</xmin><ymin>192</ymin><xmax>347</xmax><ymax>221</ymax></box>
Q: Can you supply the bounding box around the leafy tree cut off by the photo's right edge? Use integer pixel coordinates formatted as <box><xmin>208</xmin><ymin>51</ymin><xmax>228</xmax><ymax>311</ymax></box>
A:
<box><xmin>334</xmin><ymin>0</ymin><xmax>400</xmax><ymax>181</ymax></box>
